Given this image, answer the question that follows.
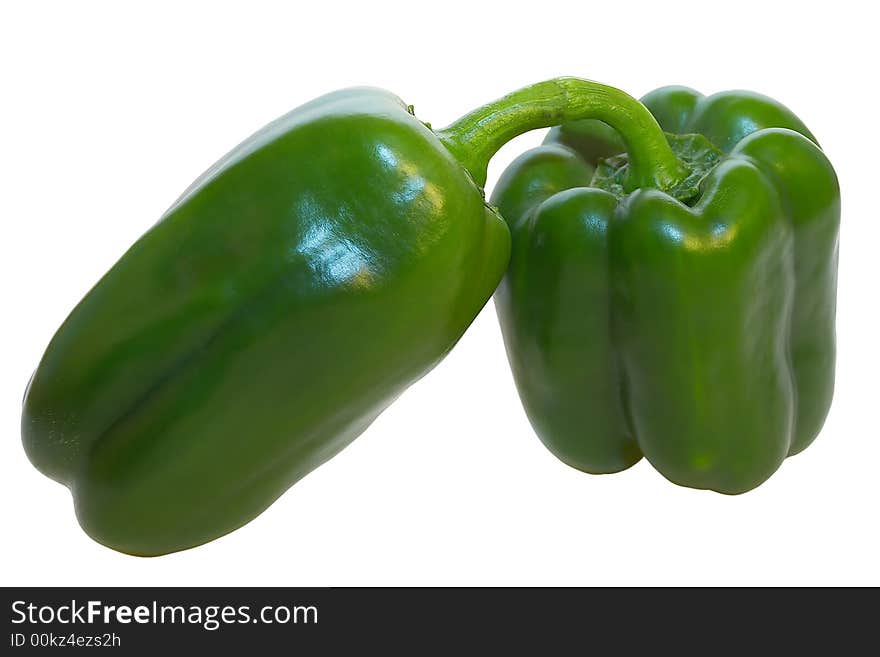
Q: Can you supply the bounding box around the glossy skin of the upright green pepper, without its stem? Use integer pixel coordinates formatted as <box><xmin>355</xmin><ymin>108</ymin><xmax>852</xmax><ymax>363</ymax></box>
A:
<box><xmin>492</xmin><ymin>87</ymin><xmax>840</xmax><ymax>494</ymax></box>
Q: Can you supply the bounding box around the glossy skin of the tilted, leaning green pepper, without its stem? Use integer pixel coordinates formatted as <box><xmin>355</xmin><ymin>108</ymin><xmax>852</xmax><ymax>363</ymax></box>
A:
<box><xmin>22</xmin><ymin>84</ymin><xmax>510</xmax><ymax>555</ymax></box>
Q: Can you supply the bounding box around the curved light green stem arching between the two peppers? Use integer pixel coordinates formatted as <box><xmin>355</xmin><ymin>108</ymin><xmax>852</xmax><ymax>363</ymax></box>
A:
<box><xmin>437</xmin><ymin>78</ymin><xmax>688</xmax><ymax>191</ymax></box>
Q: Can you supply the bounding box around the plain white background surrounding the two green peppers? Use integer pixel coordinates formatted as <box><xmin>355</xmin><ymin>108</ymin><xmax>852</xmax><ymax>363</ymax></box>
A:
<box><xmin>0</xmin><ymin>0</ymin><xmax>880</xmax><ymax>586</ymax></box>
